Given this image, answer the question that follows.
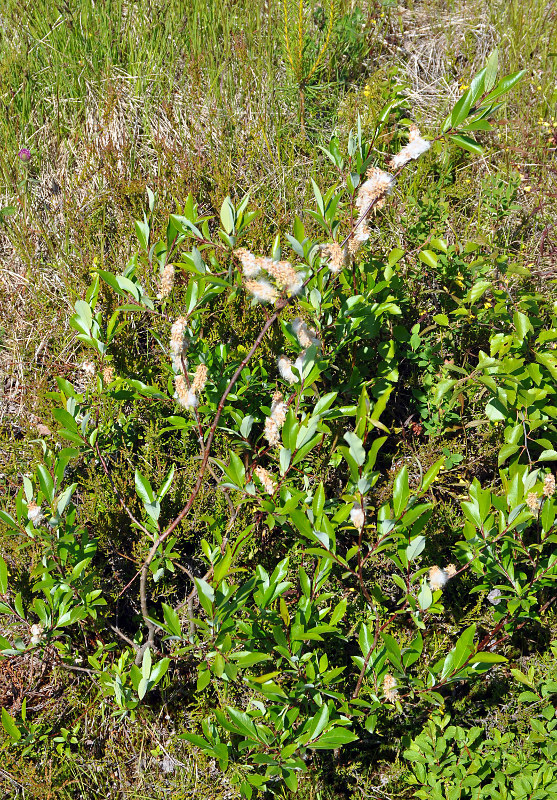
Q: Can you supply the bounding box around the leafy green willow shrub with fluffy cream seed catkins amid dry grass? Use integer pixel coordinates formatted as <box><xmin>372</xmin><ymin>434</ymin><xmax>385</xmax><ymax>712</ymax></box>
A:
<box><xmin>0</xmin><ymin>51</ymin><xmax>557</xmax><ymax>798</ymax></box>
